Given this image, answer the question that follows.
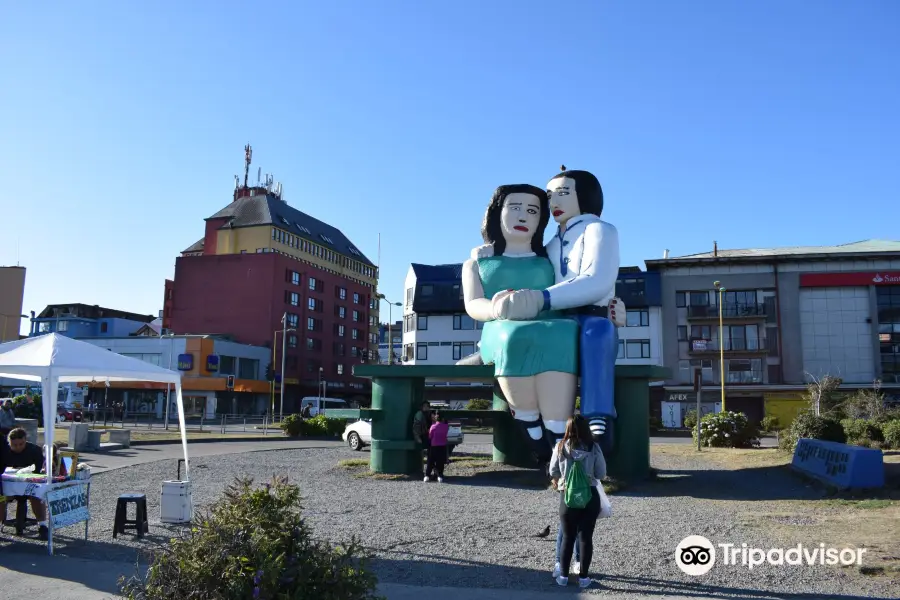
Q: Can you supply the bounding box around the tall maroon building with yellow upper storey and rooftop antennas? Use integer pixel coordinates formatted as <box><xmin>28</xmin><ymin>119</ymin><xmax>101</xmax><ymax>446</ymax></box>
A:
<box><xmin>163</xmin><ymin>173</ymin><xmax>378</xmax><ymax>412</ymax></box>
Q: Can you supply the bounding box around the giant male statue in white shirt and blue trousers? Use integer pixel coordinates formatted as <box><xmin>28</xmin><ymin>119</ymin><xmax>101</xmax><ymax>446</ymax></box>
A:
<box><xmin>473</xmin><ymin>166</ymin><xmax>625</xmax><ymax>456</ymax></box>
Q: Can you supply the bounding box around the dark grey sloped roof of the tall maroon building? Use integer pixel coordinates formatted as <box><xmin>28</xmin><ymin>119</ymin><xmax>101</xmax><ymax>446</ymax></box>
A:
<box><xmin>206</xmin><ymin>193</ymin><xmax>375</xmax><ymax>267</ymax></box>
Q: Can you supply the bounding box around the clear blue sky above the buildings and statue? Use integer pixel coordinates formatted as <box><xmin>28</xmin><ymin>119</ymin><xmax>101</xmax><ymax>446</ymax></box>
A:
<box><xmin>0</xmin><ymin>0</ymin><xmax>900</xmax><ymax>326</ymax></box>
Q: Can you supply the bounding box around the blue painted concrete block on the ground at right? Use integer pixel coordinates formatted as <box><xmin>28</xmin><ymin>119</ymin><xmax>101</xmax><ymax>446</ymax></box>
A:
<box><xmin>791</xmin><ymin>438</ymin><xmax>884</xmax><ymax>490</ymax></box>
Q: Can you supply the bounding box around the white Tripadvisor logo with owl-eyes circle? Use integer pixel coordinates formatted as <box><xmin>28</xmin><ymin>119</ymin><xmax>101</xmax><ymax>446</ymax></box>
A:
<box><xmin>675</xmin><ymin>535</ymin><xmax>866</xmax><ymax>576</ymax></box>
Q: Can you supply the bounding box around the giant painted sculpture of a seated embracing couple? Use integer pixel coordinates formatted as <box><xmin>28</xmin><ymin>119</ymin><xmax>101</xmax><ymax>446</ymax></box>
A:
<box><xmin>462</xmin><ymin>166</ymin><xmax>625</xmax><ymax>463</ymax></box>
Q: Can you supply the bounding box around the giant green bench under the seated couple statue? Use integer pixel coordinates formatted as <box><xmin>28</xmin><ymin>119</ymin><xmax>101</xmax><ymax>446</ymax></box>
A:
<box><xmin>338</xmin><ymin>365</ymin><xmax>670</xmax><ymax>479</ymax></box>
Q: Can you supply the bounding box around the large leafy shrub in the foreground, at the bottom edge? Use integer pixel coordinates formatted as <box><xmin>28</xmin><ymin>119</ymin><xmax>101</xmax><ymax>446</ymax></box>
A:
<box><xmin>121</xmin><ymin>479</ymin><xmax>377</xmax><ymax>600</ymax></box>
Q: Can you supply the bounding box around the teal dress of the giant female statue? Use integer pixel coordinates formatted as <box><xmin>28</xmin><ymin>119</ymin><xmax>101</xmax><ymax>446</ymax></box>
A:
<box><xmin>478</xmin><ymin>256</ymin><xmax>578</xmax><ymax>377</ymax></box>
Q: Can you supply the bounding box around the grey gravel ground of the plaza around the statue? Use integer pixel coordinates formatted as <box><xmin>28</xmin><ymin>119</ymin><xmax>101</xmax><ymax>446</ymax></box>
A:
<box><xmin>3</xmin><ymin>446</ymin><xmax>900</xmax><ymax>600</ymax></box>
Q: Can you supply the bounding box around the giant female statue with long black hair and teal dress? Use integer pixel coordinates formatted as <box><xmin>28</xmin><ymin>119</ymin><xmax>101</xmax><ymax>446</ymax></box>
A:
<box><xmin>462</xmin><ymin>184</ymin><xmax>579</xmax><ymax>462</ymax></box>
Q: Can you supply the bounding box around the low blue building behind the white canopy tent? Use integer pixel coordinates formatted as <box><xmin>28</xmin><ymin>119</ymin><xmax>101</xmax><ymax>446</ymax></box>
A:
<box><xmin>28</xmin><ymin>304</ymin><xmax>155</xmax><ymax>338</ymax></box>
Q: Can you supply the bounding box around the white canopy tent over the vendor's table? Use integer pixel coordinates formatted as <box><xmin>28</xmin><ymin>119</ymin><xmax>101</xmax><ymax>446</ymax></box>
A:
<box><xmin>0</xmin><ymin>333</ymin><xmax>190</xmax><ymax>482</ymax></box>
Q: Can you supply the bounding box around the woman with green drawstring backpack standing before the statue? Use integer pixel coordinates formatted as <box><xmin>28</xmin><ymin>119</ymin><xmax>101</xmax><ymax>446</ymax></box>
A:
<box><xmin>550</xmin><ymin>415</ymin><xmax>606</xmax><ymax>588</ymax></box>
